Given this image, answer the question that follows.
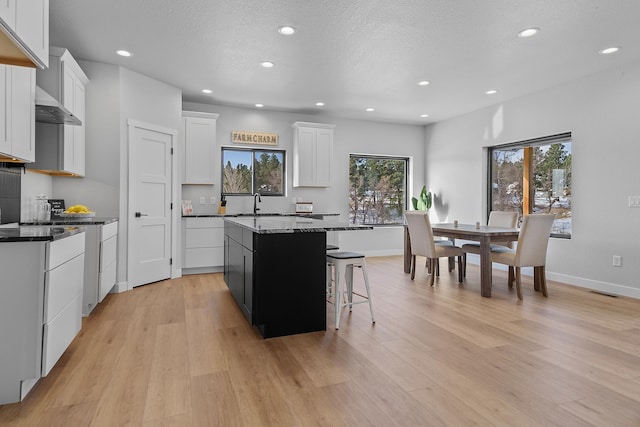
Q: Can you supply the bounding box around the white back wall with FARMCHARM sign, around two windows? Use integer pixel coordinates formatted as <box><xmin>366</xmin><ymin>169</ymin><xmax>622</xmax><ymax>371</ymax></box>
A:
<box><xmin>183</xmin><ymin>103</ymin><xmax>424</xmax><ymax>255</ymax></box>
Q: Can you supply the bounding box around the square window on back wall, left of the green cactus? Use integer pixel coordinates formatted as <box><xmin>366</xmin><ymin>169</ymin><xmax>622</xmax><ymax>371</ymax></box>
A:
<box><xmin>349</xmin><ymin>154</ymin><xmax>409</xmax><ymax>225</ymax></box>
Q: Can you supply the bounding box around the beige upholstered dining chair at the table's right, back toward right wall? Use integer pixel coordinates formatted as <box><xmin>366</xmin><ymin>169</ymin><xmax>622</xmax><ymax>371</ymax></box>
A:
<box><xmin>491</xmin><ymin>214</ymin><xmax>555</xmax><ymax>300</ymax></box>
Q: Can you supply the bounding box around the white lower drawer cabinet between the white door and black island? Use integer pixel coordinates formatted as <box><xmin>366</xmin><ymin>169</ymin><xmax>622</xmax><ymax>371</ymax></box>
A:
<box><xmin>182</xmin><ymin>217</ymin><xmax>224</xmax><ymax>274</ymax></box>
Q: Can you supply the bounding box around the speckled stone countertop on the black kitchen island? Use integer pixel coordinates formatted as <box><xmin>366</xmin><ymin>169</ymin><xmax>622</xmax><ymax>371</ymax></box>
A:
<box><xmin>224</xmin><ymin>215</ymin><xmax>373</xmax><ymax>234</ymax></box>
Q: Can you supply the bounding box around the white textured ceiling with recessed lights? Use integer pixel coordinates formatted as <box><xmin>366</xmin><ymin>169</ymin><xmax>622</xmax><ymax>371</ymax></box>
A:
<box><xmin>50</xmin><ymin>0</ymin><xmax>640</xmax><ymax>124</ymax></box>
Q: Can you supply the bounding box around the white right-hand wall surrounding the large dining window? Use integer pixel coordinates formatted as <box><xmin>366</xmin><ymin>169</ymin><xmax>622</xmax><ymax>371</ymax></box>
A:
<box><xmin>425</xmin><ymin>57</ymin><xmax>640</xmax><ymax>298</ymax></box>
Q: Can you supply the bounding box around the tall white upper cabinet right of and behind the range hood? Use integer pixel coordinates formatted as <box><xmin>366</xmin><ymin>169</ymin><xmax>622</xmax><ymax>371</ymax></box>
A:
<box><xmin>32</xmin><ymin>47</ymin><xmax>89</xmax><ymax>176</ymax></box>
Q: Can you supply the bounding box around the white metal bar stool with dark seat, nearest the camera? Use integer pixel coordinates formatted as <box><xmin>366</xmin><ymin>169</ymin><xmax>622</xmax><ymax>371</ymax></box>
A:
<box><xmin>327</xmin><ymin>252</ymin><xmax>376</xmax><ymax>329</ymax></box>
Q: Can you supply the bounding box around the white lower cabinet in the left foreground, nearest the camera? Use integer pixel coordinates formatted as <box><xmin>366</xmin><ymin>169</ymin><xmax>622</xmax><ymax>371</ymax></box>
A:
<box><xmin>0</xmin><ymin>233</ymin><xmax>85</xmax><ymax>405</ymax></box>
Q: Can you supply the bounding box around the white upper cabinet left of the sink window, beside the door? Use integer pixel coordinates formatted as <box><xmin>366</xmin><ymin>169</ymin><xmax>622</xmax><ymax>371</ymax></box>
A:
<box><xmin>181</xmin><ymin>111</ymin><xmax>220</xmax><ymax>184</ymax></box>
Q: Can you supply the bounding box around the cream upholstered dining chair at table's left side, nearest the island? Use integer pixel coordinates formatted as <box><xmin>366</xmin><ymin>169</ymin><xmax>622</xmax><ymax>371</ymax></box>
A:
<box><xmin>405</xmin><ymin>211</ymin><xmax>463</xmax><ymax>286</ymax></box>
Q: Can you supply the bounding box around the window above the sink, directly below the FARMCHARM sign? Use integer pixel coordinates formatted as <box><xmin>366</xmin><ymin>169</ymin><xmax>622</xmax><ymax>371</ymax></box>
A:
<box><xmin>222</xmin><ymin>147</ymin><xmax>285</xmax><ymax>196</ymax></box>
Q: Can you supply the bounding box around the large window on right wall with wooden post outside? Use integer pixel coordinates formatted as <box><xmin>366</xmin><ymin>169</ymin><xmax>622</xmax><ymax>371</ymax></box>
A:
<box><xmin>489</xmin><ymin>133</ymin><xmax>571</xmax><ymax>238</ymax></box>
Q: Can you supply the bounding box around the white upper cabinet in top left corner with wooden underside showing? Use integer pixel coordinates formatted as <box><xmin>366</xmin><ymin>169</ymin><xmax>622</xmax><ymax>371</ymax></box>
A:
<box><xmin>0</xmin><ymin>0</ymin><xmax>49</xmax><ymax>68</ymax></box>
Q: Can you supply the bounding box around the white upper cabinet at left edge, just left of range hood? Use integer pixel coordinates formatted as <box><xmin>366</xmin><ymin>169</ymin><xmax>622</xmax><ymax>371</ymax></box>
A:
<box><xmin>0</xmin><ymin>65</ymin><xmax>36</xmax><ymax>162</ymax></box>
